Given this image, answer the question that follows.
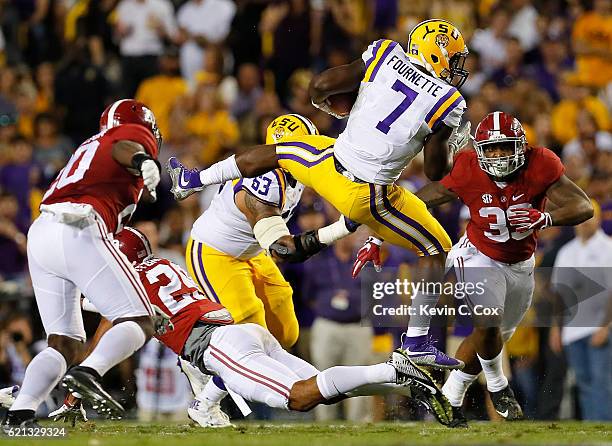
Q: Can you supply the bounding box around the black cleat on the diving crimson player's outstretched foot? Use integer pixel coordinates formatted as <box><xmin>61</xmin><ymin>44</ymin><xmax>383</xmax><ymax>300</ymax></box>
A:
<box><xmin>389</xmin><ymin>349</ymin><xmax>453</xmax><ymax>426</ymax></box>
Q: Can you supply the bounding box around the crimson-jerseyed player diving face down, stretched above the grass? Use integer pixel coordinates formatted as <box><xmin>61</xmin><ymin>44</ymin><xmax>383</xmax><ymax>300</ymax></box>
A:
<box><xmin>50</xmin><ymin>228</ymin><xmax>452</xmax><ymax>426</ymax></box>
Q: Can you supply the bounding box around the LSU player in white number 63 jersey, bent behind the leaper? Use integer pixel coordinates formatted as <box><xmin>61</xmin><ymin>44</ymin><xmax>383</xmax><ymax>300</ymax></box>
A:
<box><xmin>186</xmin><ymin>114</ymin><xmax>358</xmax><ymax>356</ymax></box>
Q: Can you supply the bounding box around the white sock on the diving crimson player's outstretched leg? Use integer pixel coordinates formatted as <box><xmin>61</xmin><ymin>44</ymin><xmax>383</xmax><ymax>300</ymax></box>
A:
<box><xmin>317</xmin><ymin>362</ymin><xmax>395</xmax><ymax>399</ymax></box>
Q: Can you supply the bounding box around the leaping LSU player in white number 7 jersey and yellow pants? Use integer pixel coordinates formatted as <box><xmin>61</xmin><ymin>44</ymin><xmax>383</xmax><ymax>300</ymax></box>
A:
<box><xmin>168</xmin><ymin>20</ymin><xmax>469</xmax><ymax>369</ymax></box>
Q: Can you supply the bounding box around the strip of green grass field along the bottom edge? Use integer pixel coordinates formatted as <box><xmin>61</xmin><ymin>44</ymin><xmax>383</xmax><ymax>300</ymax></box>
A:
<box><xmin>8</xmin><ymin>422</ymin><xmax>612</xmax><ymax>446</ymax></box>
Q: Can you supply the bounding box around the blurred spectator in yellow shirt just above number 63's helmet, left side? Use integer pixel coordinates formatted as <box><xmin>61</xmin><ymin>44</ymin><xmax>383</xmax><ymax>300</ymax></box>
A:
<box><xmin>185</xmin><ymin>77</ymin><xmax>239</xmax><ymax>165</ymax></box>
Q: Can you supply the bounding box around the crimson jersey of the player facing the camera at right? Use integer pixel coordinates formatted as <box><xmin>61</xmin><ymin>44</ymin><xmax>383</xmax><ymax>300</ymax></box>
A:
<box><xmin>440</xmin><ymin>147</ymin><xmax>565</xmax><ymax>263</ymax></box>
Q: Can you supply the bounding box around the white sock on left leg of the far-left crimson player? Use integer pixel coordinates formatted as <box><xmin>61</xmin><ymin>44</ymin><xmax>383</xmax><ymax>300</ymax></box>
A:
<box><xmin>11</xmin><ymin>347</ymin><xmax>67</xmax><ymax>411</ymax></box>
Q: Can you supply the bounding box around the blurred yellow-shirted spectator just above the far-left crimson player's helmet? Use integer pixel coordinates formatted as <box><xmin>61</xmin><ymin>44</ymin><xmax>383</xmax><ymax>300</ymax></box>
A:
<box><xmin>136</xmin><ymin>47</ymin><xmax>188</xmax><ymax>140</ymax></box>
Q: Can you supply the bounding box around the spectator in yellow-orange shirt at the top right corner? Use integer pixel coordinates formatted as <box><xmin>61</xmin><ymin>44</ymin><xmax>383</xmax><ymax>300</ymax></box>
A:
<box><xmin>572</xmin><ymin>0</ymin><xmax>612</xmax><ymax>88</ymax></box>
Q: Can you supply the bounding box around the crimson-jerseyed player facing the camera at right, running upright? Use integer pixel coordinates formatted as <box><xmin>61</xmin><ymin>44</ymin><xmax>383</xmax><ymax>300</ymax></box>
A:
<box><xmin>417</xmin><ymin>111</ymin><xmax>593</xmax><ymax>427</ymax></box>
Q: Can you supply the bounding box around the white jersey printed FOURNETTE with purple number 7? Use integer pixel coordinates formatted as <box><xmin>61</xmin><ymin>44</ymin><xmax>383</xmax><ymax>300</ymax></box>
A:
<box><xmin>334</xmin><ymin>40</ymin><xmax>465</xmax><ymax>184</ymax></box>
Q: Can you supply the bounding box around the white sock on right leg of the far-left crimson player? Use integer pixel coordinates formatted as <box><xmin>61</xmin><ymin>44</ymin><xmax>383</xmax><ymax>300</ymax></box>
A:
<box><xmin>80</xmin><ymin>321</ymin><xmax>146</xmax><ymax>375</ymax></box>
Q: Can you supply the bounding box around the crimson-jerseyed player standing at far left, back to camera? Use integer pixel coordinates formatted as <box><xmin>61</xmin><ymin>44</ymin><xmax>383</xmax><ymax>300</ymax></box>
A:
<box><xmin>4</xmin><ymin>99</ymin><xmax>161</xmax><ymax>427</ymax></box>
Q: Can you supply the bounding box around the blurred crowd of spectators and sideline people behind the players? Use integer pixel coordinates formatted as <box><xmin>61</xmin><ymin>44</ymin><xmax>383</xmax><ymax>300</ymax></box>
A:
<box><xmin>0</xmin><ymin>0</ymin><xmax>612</xmax><ymax>421</ymax></box>
